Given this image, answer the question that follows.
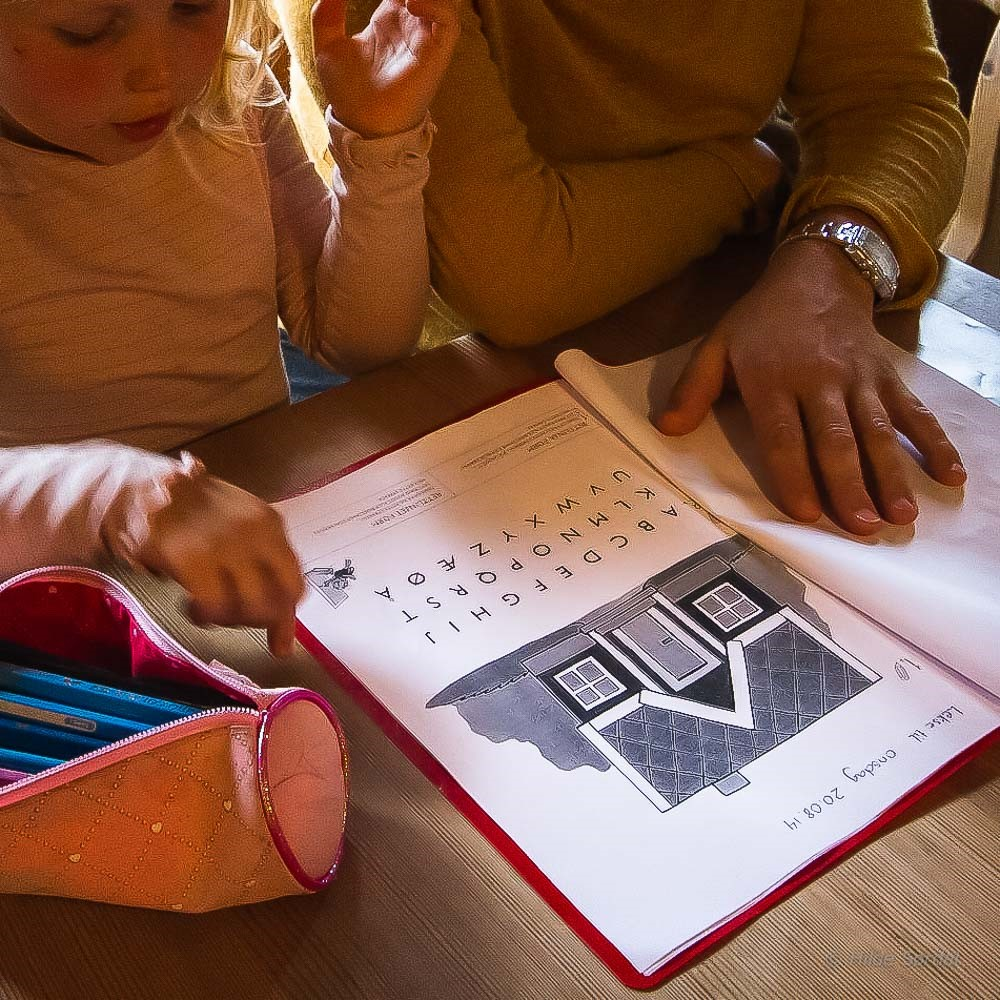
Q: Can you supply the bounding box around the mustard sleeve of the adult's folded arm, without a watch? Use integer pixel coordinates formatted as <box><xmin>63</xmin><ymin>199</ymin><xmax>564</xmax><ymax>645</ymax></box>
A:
<box><xmin>414</xmin><ymin>3</ymin><xmax>779</xmax><ymax>346</ymax></box>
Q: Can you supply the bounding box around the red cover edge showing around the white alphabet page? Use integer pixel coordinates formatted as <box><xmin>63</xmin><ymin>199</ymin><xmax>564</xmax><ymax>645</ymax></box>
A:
<box><xmin>286</xmin><ymin>379</ymin><xmax>1000</xmax><ymax>990</ymax></box>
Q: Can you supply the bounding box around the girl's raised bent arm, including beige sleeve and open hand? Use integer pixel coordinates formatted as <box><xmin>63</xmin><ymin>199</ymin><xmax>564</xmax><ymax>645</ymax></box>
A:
<box><xmin>264</xmin><ymin>0</ymin><xmax>458</xmax><ymax>372</ymax></box>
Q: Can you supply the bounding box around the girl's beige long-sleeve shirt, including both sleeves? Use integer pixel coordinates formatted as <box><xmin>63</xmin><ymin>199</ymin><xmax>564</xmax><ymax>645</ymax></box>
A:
<box><xmin>0</xmin><ymin>104</ymin><xmax>432</xmax><ymax>575</ymax></box>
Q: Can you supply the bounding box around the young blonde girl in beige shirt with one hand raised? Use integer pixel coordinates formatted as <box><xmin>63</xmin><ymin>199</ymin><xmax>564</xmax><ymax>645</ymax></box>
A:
<box><xmin>0</xmin><ymin>0</ymin><xmax>459</xmax><ymax>654</ymax></box>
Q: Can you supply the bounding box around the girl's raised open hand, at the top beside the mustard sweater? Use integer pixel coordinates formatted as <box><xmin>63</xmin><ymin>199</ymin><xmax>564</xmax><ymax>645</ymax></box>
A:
<box><xmin>312</xmin><ymin>0</ymin><xmax>460</xmax><ymax>139</ymax></box>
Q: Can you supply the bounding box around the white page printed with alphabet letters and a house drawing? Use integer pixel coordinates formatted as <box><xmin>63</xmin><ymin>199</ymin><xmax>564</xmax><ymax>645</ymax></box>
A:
<box><xmin>278</xmin><ymin>384</ymin><xmax>1000</xmax><ymax>972</ymax></box>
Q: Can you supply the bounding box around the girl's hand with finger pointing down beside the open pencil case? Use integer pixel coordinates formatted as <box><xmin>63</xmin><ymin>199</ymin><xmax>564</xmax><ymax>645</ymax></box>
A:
<box><xmin>135</xmin><ymin>473</ymin><xmax>304</xmax><ymax>656</ymax></box>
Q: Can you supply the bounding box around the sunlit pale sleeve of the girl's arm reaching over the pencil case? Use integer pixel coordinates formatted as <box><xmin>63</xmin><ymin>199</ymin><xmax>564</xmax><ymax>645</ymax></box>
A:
<box><xmin>0</xmin><ymin>441</ymin><xmax>194</xmax><ymax>578</ymax></box>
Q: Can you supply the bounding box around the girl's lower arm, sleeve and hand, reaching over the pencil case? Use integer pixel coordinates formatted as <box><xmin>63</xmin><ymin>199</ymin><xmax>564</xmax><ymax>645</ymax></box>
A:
<box><xmin>0</xmin><ymin>441</ymin><xmax>303</xmax><ymax>655</ymax></box>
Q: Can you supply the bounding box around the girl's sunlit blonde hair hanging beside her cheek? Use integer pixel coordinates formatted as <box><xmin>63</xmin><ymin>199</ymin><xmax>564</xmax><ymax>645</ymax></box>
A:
<box><xmin>187</xmin><ymin>0</ymin><xmax>281</xmax><ymax>141</ymax></box>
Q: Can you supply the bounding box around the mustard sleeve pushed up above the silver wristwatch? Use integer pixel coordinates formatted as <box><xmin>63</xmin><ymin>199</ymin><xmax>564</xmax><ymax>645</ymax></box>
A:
<box><xmin>782</xmin><ymin>0</ymin><xmax>968</xmax><ymax>308</ymax></box>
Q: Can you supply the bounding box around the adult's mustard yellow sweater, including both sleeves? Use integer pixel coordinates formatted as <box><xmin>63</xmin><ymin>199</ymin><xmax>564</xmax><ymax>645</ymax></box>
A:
<box><xmin>338</xmin><ymin>0</ymin><xmax>967</xmax><ymax>344</ymax></box>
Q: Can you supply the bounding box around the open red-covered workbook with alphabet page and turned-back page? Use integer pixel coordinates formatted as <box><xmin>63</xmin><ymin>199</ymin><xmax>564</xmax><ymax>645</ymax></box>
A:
<box><xmin>278</xmin><ymin>349</ymin><xmax>1000</xmax><ymax>986</ymax></box>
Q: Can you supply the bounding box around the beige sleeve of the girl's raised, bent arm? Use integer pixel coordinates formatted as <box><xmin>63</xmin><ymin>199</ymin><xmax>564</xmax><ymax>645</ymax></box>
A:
<box><xmin>263</xmin><ymin>92</ymin><xmax>433</xmax><ymax>372</ymax></box>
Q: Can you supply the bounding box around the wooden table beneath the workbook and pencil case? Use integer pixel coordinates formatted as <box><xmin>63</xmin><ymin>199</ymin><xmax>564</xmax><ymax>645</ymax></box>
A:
<box><xmin>0</xmin><ymin>243</ymin><xmax>1000</xmax><ymax>1000</ymax></box>
